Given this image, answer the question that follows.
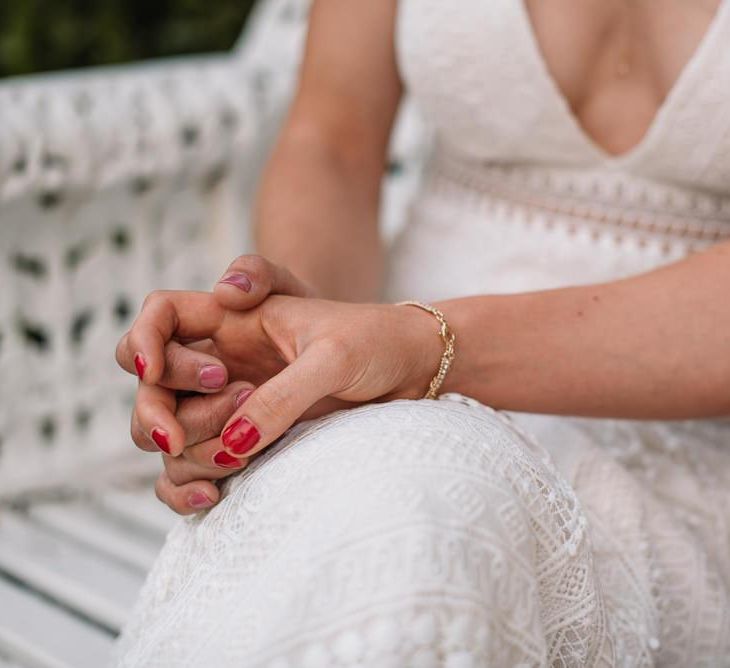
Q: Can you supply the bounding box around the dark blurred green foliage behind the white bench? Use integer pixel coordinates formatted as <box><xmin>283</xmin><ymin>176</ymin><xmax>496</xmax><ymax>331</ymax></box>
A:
<box><xmin>0</xmin><ymin>0</ymin><xmax>254</xmax><ymax>76</ymax></box>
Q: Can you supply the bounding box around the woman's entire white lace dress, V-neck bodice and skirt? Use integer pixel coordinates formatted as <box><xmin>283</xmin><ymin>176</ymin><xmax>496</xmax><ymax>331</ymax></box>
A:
<box><xmin>117</xmin><ymin>0</ymin><xmax>730</xmax><ymax>668</ymax></box>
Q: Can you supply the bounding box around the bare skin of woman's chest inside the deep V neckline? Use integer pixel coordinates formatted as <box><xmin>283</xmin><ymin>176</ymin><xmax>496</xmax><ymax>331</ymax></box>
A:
<box><xmin>525</xmin><ymin>0</ymin><xmax>720</xmax><ymax>154</ymax></box>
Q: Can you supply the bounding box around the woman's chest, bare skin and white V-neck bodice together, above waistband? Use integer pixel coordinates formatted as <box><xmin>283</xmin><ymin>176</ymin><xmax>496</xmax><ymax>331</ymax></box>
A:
<box><xmin>395</xmin><ymin>0</ymin><xmax>730</xmax><ymax>187</ymax></box>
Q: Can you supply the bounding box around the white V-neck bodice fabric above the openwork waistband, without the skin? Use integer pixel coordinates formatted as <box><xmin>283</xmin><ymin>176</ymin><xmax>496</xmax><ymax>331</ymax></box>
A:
<box><xmin>397</xmin><ymin>0</ymin><xmax>730</xmax><ymax>194</ymax></box>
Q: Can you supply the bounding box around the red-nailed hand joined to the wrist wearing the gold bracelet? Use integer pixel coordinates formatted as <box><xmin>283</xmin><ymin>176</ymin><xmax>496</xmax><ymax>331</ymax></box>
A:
<box><xmin>117</xmin><ymin>292</ymin><xmax>443</xmax><ymax>457</ymax></box>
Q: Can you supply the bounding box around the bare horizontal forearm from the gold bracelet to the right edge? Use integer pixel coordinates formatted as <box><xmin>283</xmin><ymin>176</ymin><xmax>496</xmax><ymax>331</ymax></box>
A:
<box><xmin>440</xmin><ymin>244</ymin><xmax>730</xmax><ymax>419</ymax></box>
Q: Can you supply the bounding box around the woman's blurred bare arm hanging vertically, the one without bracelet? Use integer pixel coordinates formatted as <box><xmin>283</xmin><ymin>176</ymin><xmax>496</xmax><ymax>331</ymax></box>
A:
<box><xmin>249</xmin><ymin>0</ymin><xmax>402</xmax><ymax>301</ymax></box>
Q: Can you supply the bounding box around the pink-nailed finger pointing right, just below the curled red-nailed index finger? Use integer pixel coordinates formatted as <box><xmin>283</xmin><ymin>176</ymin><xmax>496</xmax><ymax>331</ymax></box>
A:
<box><xmin>158</xmin><ymin>341</ymin><xmax>228</xmax><ymax>392</ymax></box>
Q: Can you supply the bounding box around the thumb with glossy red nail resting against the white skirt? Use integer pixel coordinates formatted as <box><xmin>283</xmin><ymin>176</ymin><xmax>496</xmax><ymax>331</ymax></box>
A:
<box><xmin>221</xmin><ymin>346</ymin><xmax>339</xmax><ymax>457</ymax></box>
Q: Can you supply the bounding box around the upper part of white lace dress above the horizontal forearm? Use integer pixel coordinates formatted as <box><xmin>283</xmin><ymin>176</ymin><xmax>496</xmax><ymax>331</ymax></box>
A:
<box><xmin>388</xmin><ymin>0</ymin><xmax>730</xmax><ymax>300</ymax></box>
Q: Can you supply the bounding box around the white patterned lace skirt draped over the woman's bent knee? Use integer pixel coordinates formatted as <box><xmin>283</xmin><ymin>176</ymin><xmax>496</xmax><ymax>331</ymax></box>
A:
<box><xmin>115</xmin><ymin>395</ymin><xmax>730</xmax><ymax>668</ymax></box>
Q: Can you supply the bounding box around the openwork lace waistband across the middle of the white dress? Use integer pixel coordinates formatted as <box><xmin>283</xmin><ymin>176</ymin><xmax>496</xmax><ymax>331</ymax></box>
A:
<box><xmin>428</xmin><ymin>151</ymin><xmax>730</xmax><ymax>253</ymax></box>
